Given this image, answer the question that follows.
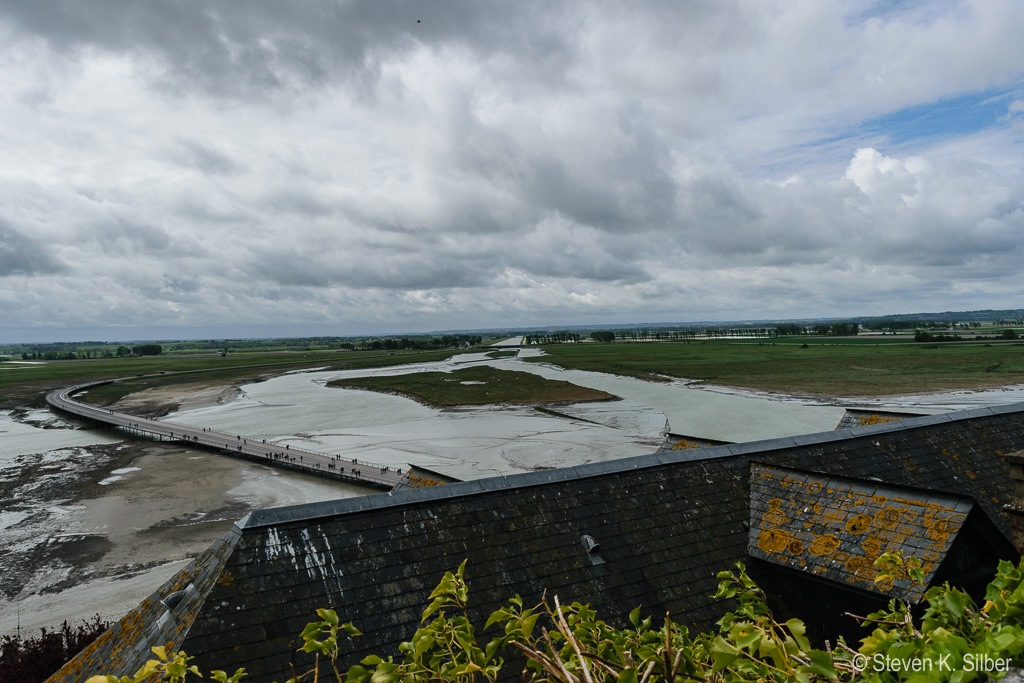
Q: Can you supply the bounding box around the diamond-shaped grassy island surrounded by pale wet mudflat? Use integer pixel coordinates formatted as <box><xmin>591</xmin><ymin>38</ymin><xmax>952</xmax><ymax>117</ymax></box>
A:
<box><xmin>327</xmin><ymin>366</ymin><xmax>615</xmax><ymax>408</ymax></box>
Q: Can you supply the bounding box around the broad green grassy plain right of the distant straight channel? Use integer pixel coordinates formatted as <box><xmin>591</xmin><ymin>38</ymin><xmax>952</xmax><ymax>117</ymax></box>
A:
<box><xmin>528</xmin><ymin>338</ymin><xmax>1024</xmax><ymax>396</ymax></box>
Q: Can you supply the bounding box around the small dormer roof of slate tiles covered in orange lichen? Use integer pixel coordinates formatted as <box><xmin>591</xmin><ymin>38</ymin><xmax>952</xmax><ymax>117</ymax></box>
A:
<box><xmin>748</xmin><ymin>463</ymin><xmax>974</xmax><ymax>602</ymax></box>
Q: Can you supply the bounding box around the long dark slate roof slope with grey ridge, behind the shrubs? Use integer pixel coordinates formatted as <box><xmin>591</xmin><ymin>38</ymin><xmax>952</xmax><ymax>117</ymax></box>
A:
<box><xmin>51</xmin><ymin>404</ymin><xmax>1024</xmax><ymax>682</ymax></box>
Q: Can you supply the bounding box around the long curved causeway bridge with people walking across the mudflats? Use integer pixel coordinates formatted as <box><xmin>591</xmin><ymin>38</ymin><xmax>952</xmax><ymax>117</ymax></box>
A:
<box><xmin>46</xmin><ymin>380</ymin><xmax>402</xmax><ymax>490</ymax></box>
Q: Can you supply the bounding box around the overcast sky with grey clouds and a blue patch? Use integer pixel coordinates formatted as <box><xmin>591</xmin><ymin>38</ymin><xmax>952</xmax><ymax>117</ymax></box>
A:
<box><xmin>0</xmin><ymin>0</ymin><xmax>1024</xmax><ymax>341</ymax></box>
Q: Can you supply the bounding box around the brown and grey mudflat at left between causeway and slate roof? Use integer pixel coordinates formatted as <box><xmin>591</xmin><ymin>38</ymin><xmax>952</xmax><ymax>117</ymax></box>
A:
<box><xmin>0</xmin><ymin>411</ymin><xmax>370</xmax><ymax>635</ymax></box>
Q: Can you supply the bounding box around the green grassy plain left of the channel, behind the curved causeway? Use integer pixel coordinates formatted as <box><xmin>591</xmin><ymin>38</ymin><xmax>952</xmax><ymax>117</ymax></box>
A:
<box><xmin>0</xmin><ymin>349</ymin><xmax>477</xmax><ymax>409</ymax></box>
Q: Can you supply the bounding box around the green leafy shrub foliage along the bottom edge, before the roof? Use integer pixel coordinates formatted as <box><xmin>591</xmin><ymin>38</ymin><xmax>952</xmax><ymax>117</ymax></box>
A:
<box><xmin>87</xmin><ymin>553</ymin><xmax>1024</xmax><ymax>683</ymax></box>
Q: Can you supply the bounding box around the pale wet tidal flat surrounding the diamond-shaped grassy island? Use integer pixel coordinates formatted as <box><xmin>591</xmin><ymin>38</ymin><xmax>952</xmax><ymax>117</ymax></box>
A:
<box><xmin>166</xmin><ymin>349</ymin><xmax>843</xmax><ymax>479</ymax></box>
